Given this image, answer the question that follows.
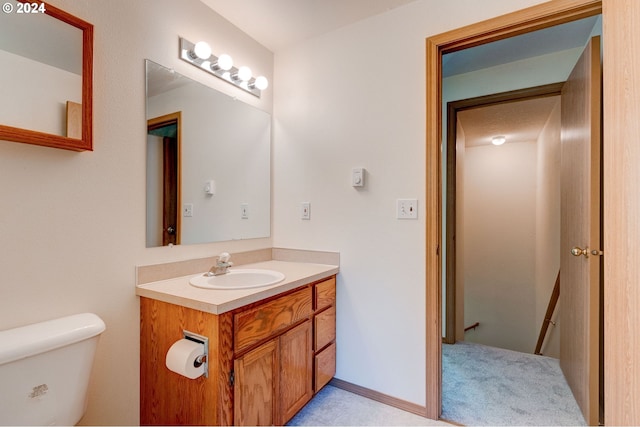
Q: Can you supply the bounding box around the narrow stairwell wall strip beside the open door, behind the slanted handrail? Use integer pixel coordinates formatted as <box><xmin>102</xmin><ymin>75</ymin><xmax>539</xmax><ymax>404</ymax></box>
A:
<box><xmin>535</xmin><ymin>99</ymin><xmax>561</xmax><ymax>358</ymax></box>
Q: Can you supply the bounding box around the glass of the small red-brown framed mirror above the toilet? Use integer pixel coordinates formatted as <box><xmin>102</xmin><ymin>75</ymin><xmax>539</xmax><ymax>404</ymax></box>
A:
<box><xmin>0</xmin><ymin>1</ymin><xmax>82</xmax><ymax>136</ymax></box>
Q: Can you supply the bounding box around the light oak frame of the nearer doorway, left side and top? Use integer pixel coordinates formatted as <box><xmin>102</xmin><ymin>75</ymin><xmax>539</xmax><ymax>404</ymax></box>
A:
<box><xmin>425</xmin><ymin>0</ymin><xmax>602</xmax><ymax>419</ymax></box>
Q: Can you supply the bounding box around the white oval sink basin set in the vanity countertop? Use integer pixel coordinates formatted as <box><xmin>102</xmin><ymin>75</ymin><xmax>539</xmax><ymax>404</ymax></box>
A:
<box><xmin>189</xmin><ymin>268</ymin><xmax>284</xmax><ymax>289</ymax></box>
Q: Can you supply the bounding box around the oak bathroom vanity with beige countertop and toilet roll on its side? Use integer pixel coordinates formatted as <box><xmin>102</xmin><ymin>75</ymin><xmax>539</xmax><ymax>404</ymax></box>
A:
<box><xmin>136</xmin><ymin>252</ymin><xmax>338</xmax><ymax>425</ymax></box>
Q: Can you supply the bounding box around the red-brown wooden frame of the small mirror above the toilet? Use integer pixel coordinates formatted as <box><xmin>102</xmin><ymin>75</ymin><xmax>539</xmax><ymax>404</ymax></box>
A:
<box><xmin>0</xmin><ymin>0</ymin><xmax>93</xmax><ymax>151</ymax></box>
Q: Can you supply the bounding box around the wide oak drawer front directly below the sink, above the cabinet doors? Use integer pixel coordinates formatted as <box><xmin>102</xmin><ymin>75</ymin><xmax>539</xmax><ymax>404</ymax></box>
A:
<box><xmin>233</xmin><ymin>287</ymin><xmax>312</xmax><ymax>352</ymax></box>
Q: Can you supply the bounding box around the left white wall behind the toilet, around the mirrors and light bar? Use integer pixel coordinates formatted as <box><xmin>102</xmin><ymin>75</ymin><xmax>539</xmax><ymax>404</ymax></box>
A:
<box><xmin>0</xmin><ymin>0</ymin><xmax>273</xmax><ymax>425</ymax></box>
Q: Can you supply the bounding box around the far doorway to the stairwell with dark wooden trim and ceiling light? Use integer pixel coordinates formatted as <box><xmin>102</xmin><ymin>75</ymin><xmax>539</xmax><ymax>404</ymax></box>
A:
<box><xmin>443</xmin><ymin>83</ymin><xmax>562</xmax><ymax>357</ymax></box>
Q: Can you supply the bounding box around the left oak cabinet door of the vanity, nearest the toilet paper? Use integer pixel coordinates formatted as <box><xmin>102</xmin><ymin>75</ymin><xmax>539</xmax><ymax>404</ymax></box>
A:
<box><xmin>233</xmin><ymin>338</ymin><xmax>279</xmax><ymax>426</ymax></box>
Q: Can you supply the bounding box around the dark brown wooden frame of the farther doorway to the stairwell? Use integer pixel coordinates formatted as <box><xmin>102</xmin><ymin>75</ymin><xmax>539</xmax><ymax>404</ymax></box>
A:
<box><xmin>443</xmin><ymin>82</ymin><xmax>564</xmax><ymax>344</ymax></box>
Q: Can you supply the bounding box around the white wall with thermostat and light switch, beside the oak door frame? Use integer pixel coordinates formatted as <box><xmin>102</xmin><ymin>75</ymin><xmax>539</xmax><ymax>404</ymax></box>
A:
<box><xmin>274</xmin><ymin>0</ymin><xmax>541</xmax><ymax>405</ymax></box>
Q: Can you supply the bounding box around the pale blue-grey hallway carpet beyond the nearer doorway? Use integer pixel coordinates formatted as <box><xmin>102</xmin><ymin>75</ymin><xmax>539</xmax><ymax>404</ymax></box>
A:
<box><xmin>442</xmin><ymin>342</ymin><xmax>585</xmax><ymax>426</ymax></box>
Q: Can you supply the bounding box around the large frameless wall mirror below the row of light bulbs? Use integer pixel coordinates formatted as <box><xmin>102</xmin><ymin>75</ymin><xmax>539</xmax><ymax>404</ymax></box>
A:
<box><xmin>146</xmin><ymin>60</ymin><xmax>271</xmax><ymax>247</ymax></box>
